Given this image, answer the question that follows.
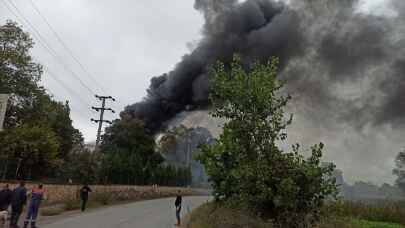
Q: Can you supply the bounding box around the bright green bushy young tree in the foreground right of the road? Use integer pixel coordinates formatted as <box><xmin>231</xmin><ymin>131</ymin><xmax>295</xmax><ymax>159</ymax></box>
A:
<box><xmin>198</xmin><ymin>58</ymin><xmax>337</xmax><ymax>227</ymax></box>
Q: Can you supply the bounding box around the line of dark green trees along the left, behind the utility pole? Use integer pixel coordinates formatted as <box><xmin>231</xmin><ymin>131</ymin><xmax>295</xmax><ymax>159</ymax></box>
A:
<box><xmin>0</xmin><ymin>21</ymin><xmax>191</xmax><ymax>186</ymax></box>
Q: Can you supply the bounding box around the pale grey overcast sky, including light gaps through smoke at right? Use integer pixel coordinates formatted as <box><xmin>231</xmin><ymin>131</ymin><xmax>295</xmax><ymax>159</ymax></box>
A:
<box><xmin>0</xmin><ymin>0</ymin><xmax>396</xmax><ymax>183</ymax></box>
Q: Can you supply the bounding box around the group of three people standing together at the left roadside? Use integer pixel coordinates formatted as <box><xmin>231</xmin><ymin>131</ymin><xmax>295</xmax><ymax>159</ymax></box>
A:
<box><xmin>0</xmin><ymin>181</ymin><xmax>44</xmax><ymax>228</ymax></box>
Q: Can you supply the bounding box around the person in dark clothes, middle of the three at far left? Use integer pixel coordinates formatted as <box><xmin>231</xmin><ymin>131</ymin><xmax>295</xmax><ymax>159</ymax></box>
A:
<box><xmin>10</xmin><ymin>181</ymin><xmax>27</xmax><ymax>228</ymax></box>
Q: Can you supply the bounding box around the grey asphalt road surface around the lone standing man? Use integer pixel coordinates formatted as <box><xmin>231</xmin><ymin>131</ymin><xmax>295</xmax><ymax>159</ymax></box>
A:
<box><xmin>41</xmin><ymin>196</ymin><xmax>210</xmax><ymax>228</ymax></box>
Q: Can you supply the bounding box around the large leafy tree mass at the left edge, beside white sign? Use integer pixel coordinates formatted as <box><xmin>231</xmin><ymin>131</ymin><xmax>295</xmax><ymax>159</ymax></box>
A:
<box><xmin>0</xmin><ymin>21</ymin><xmax>83</xmax><ymax>178</ymax></box>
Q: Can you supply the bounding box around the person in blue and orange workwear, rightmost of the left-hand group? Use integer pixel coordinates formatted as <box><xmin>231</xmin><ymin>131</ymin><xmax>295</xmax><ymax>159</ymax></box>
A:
<box><xmin>24</xmin><ymin>184</ymin><xmax>44</xmax><ymax>228</ymax></box>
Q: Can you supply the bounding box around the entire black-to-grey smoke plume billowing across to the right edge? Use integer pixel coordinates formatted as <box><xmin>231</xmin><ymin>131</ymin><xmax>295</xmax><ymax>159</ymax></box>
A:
<box><xmin>125</xmin><ymin>0</ymin><xmax>405</xmax><ymax>182</ymax></box>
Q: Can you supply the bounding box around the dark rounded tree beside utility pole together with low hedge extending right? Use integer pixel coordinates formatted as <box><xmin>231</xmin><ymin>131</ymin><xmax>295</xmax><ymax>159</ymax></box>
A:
<box><xmin>100</xmin><ymin>116</ymin><xmax>191</xmax><ymax>186</ymax></box>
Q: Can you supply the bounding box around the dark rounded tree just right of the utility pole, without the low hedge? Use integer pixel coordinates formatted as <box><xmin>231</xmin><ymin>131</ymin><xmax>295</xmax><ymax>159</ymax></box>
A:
<box><xmin>101</xmin><ymin>116</ymin><xmax>163</xmax><ymax>184</ymax></box>
